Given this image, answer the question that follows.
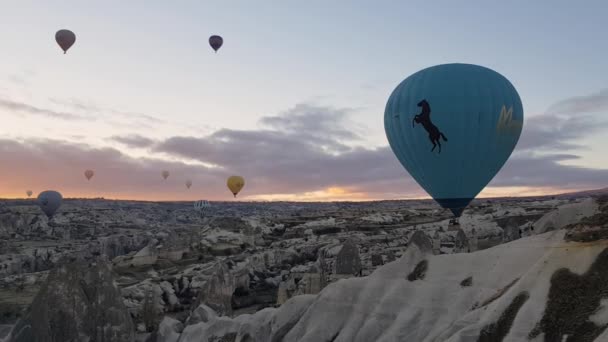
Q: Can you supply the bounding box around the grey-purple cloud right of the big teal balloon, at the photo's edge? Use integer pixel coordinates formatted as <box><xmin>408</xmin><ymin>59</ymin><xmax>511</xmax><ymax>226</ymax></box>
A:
<box><xmin>489</xmin><ymin>90</ymin><xmax>608</xmax><ymax>189</ymax></box>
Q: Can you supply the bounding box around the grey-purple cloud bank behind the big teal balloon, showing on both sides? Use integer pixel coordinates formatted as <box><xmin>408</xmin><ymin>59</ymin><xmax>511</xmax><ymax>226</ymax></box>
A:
<box><xmin>153</xmin><ymin>99</ymin><xmax>608</xmax><ymax>198</ymax></box>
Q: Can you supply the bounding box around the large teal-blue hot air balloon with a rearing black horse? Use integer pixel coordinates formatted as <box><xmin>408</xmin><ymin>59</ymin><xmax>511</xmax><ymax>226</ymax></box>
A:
<box><xmin>384</xmin><ymin>64</ymin><xmax>524</xmax><ymax>217</ymax></box>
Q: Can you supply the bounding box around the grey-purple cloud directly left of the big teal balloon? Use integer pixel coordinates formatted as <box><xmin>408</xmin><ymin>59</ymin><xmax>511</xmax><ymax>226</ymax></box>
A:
<box><xmin>154</xmin><ymin>105</ymin><xmax>414</xmax><ymax>193</ymax></box>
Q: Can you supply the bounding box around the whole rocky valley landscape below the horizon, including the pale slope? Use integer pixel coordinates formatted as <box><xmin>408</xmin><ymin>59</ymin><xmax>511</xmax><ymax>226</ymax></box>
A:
<box><xmin>0</xmin><ymin>193</ymin><xmax>608</xmax><ymax>342</ymax></box>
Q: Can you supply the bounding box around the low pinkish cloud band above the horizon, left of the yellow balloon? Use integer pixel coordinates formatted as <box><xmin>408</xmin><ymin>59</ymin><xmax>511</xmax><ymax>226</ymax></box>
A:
<box><xmin>0</xmin><ymin>139</ymin><xmax>227</xmax><ymax>200</ymax></box>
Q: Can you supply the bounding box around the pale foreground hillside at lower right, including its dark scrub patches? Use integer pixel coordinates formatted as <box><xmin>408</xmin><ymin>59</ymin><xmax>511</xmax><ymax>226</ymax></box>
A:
<box><xmin>158</xmin><ymin>199</ymin><xmax>608</xmax><ymax>342</ymax></box>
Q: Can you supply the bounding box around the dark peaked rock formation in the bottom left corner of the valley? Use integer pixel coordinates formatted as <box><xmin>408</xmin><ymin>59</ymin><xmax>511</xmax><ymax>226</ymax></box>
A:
<box><xmin>11</xmin><ymin>261</ymin><xmax>134</xmax><ymax>342</ymax></box>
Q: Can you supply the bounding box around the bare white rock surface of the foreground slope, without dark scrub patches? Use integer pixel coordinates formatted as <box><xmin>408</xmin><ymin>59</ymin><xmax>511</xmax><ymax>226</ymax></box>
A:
<box><xmin>170</xmin><ymin>231</ymin><xmax>606</xmax><ymax>342</ymax></box>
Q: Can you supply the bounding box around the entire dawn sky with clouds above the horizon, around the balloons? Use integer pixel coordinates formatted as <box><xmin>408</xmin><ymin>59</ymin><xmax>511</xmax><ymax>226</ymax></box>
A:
<box><xmin>0</xmin><ymin>0</ymin><xmax>608</xmax><ymax>201</ymax></box>
